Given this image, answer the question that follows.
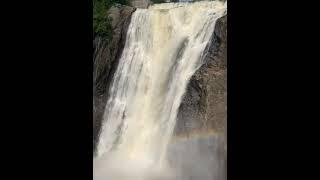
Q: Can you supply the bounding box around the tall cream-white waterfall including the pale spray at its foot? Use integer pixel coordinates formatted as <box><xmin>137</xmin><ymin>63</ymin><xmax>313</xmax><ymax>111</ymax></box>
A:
<box><xmin>93</xmin><ymin>1</ymin><xmax>226</xmax><ymax>180</ymax></box>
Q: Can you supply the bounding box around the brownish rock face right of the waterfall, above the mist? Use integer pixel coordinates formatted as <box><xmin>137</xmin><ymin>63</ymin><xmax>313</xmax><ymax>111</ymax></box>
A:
<box><xmin>175</xmin><ymin>16</ymin><xmax>227</xmax><ymax>134</ymax></box>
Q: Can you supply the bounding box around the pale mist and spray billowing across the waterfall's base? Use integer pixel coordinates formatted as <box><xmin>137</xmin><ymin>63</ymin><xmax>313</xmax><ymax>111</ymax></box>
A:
<box><xmin>94</xmin><ymin>136</ymin><xmax>226</xmax><ymax>180</ymax></box>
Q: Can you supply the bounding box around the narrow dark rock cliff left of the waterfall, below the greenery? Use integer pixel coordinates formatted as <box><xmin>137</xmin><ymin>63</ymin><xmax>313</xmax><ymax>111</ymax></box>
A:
<box><xmin>93</xmin><ymin>5</ymin><xmax>135</xmax><ymax>155</ymax></box>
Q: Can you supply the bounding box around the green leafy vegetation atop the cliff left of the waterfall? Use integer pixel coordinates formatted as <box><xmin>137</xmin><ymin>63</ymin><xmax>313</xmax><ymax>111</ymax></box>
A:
<box><xmin>93</xmin><ymin>0</ymin><xmax>128</xmax><ymax>39</ymax></box>
